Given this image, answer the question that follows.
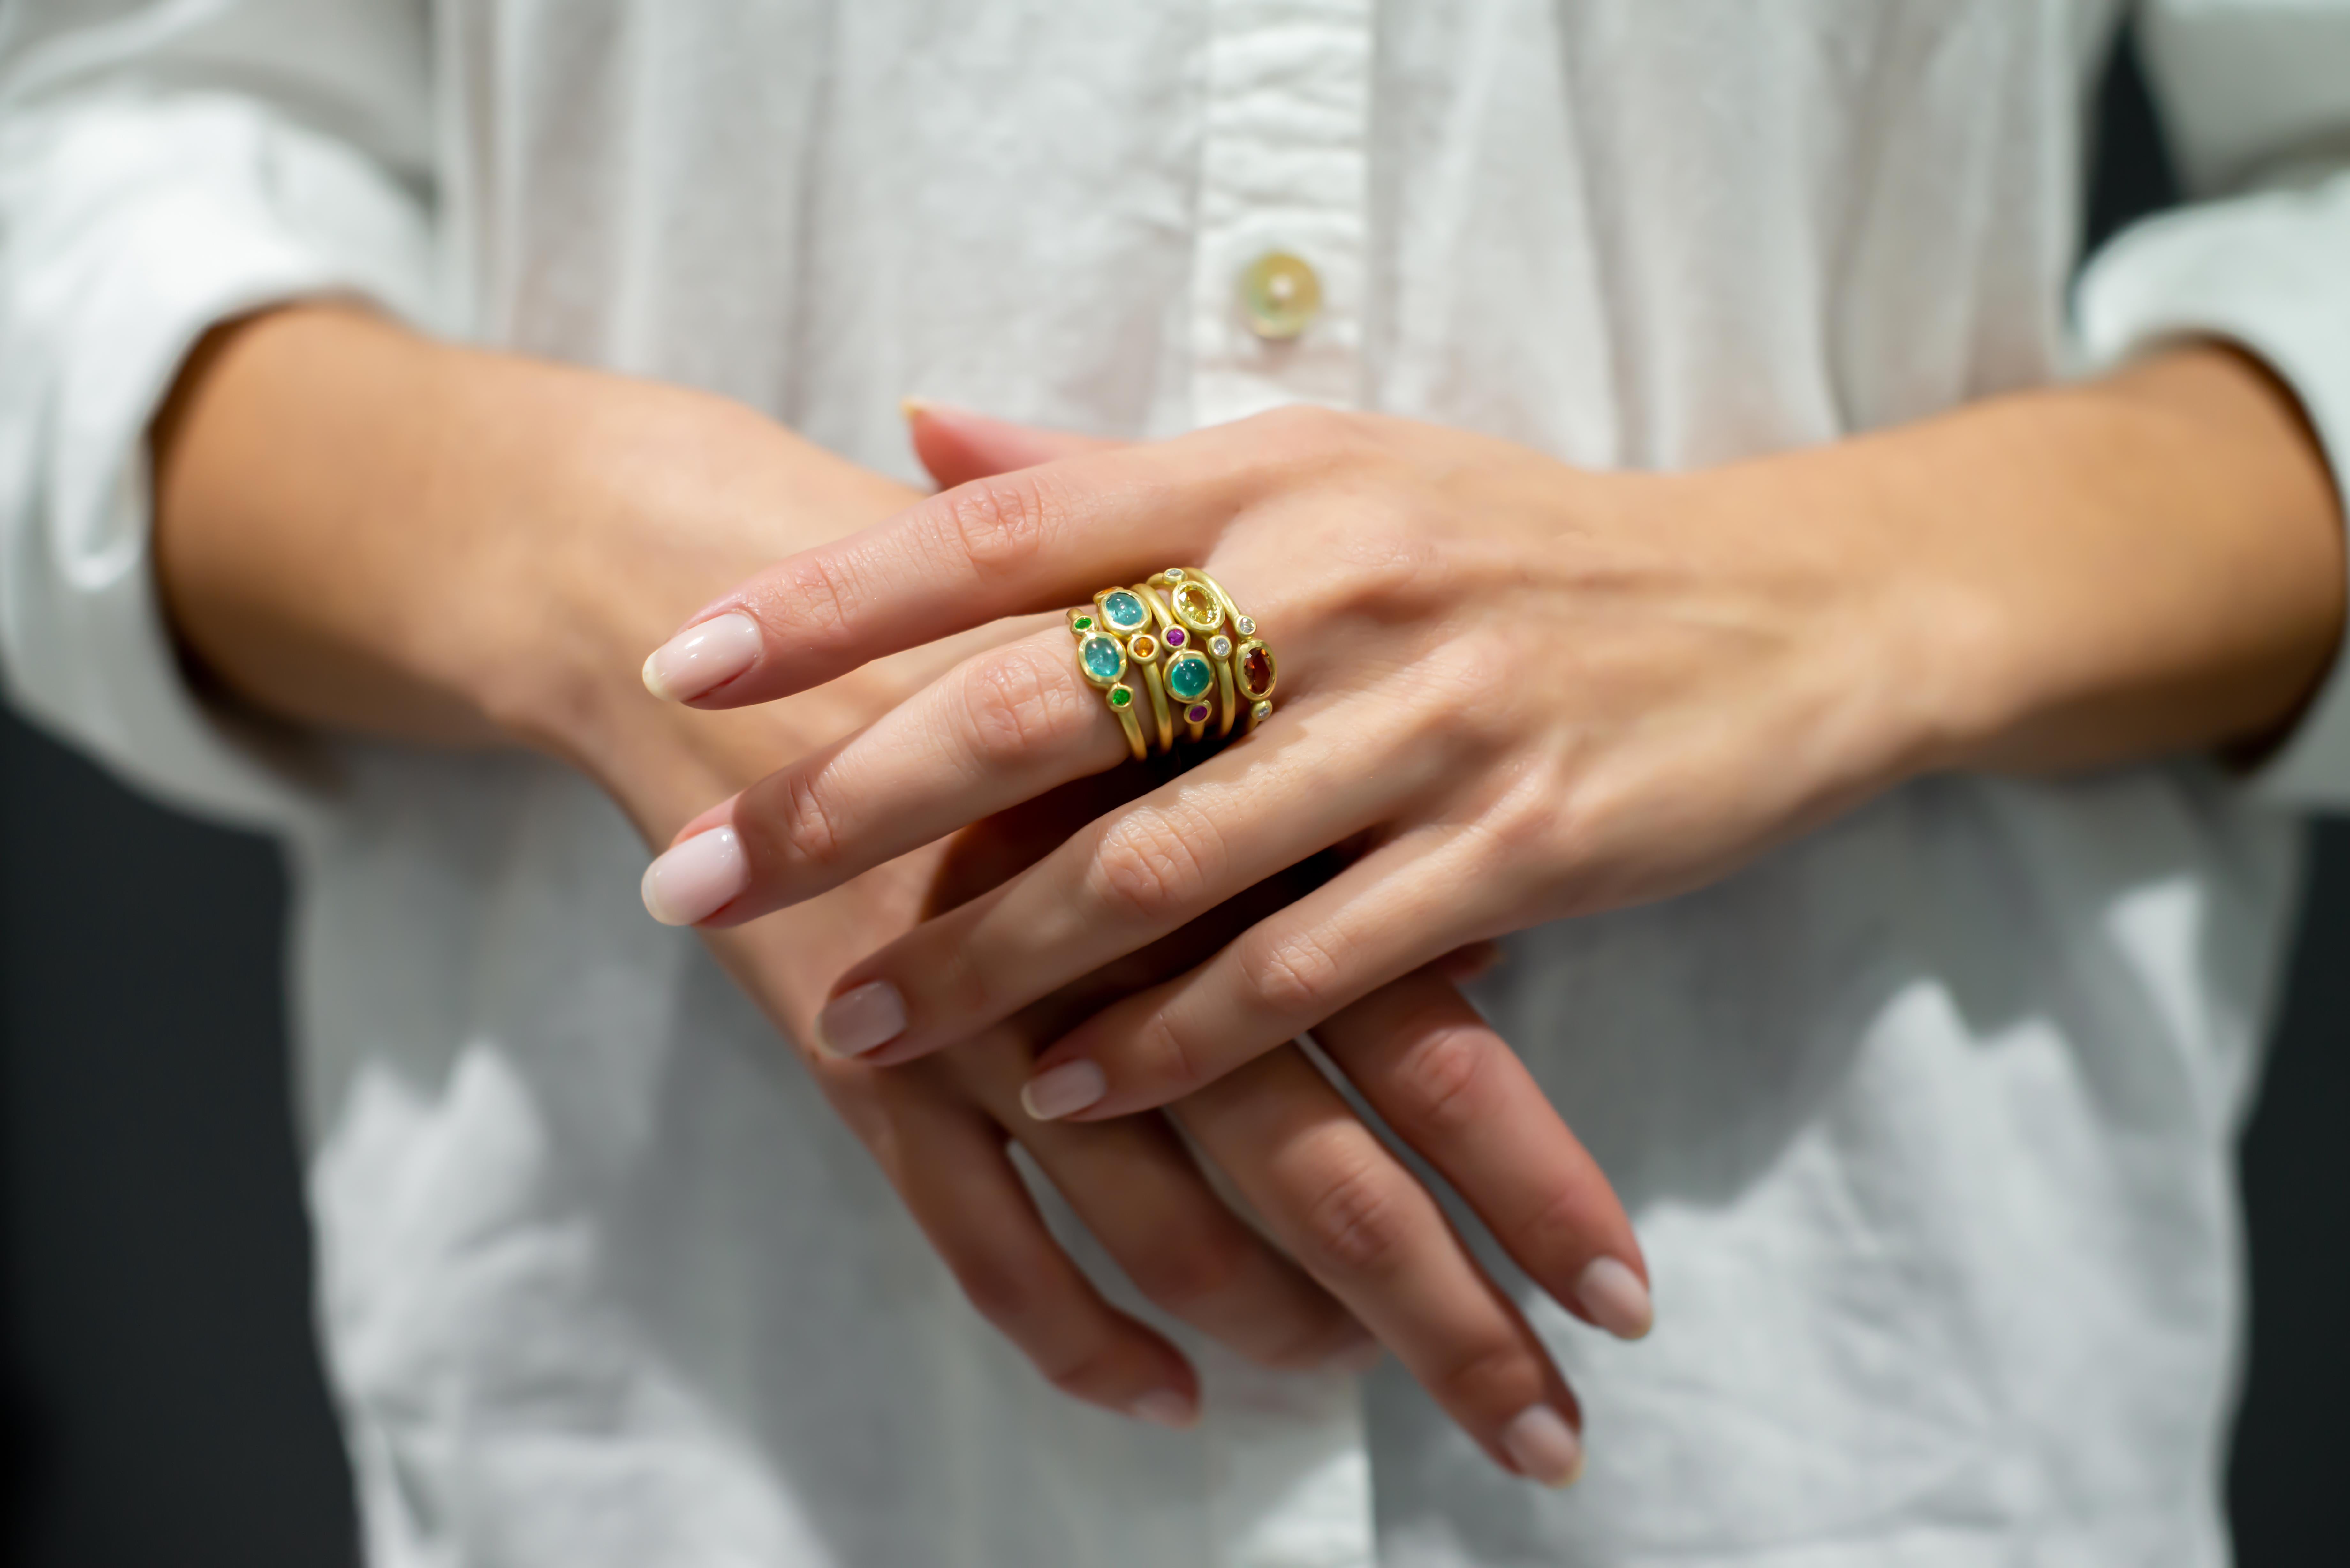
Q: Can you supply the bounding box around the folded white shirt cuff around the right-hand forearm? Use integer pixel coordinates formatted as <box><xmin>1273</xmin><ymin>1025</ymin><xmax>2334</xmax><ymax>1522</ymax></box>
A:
<box><xmin>2080</xmin><ymin>174</ymin><xmax>2350</xmax><ymax>809</ymax></box>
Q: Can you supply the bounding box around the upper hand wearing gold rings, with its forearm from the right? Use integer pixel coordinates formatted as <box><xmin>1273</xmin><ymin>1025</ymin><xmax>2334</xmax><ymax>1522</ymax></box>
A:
<box><xmin>653</xmin><ymin>348</ymin><xmax>2341</xmax><ymax>1119</ymax></box>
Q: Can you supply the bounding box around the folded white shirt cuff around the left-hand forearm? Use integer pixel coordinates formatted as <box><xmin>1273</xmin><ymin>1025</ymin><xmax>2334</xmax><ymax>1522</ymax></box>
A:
<box><xmin>0</xmin><ymin>96</ymin><xmax>432</xmax><ymax>825</ymax></box>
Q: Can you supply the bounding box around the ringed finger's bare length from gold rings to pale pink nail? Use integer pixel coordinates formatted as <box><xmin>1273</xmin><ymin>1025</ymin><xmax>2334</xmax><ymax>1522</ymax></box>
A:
<box><xmin>644</xmin><ymin>632</ymin><xmax>1128</xmax><ymax>931</ymax></box>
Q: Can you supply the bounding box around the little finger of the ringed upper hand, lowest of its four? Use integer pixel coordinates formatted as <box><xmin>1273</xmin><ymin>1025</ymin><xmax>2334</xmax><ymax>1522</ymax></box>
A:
<box><xmin>1020</xmin><ymin>830</ymin><xmax>1490</xmax><ymax>1121</ymax></box>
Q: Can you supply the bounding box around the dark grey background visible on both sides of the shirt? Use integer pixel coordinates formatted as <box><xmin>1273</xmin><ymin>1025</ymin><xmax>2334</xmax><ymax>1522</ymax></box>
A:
<box><xmin>0</xmin><ymin>24</ymin><xmax>2350</xmax><ymax>1568</ymax></box>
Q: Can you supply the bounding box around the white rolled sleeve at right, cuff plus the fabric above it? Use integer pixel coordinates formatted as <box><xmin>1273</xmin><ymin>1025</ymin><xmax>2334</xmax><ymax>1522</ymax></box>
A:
<box><xmin>2077</xmin><ymin>0</ymin><xmax>2350</xmax><ymax>809</ymax></box>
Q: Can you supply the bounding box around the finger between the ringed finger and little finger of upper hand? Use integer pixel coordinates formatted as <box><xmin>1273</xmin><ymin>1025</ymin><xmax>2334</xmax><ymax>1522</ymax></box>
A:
<box><xmin>818</xmin><ymin>677</ymin><xmax>1443</xmax><ymax>1063</ymax></box>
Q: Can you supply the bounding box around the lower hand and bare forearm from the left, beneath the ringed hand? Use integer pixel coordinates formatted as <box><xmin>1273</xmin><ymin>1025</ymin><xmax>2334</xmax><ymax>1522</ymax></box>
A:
<box><xmin>153</xmin><ymin>305</ymin><xmax>1645</xmax><ymax>1483</ymax></box>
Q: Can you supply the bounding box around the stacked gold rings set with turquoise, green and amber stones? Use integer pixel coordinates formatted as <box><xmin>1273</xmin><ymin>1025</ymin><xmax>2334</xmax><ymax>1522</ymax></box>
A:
<box><xmin>1069</xmin><ymin>567</ymin><xmax>1278</xmax><ymax>762</ymax></box>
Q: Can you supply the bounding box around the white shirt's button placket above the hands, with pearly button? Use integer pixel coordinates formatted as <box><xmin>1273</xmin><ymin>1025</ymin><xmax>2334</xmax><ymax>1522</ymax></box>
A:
<box><xmin>1192</xmin><ymin>0</ymin><xmax>1372</xmax><ymax>426</ymax></box>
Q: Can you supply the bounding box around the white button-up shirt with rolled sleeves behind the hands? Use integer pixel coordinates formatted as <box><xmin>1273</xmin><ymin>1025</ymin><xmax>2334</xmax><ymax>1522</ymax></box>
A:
<box><xmin>0</xmin><ymin>0</ymin><xmax>2350</xmax><ymax>1568</ymax></box>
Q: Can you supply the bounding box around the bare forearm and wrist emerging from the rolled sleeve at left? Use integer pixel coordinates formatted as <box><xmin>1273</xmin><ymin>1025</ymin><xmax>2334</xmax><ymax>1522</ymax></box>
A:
<box><xmin>155</xmin><ymin>308</ymin><xmax>912</xmax><ymax>823</ymax></box>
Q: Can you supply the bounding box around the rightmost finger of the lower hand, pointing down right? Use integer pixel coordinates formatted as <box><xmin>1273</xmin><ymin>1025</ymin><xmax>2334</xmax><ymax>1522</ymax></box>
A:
<box><xmin>1314</xmin><ymin>969</ymin><xmax>1654</xmax><ymax>1340</ymax></box>
